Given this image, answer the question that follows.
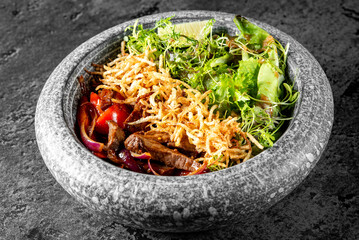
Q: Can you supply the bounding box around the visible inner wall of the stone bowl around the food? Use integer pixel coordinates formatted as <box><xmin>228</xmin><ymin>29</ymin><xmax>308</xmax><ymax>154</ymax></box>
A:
<box><xmin>63</xmin><ymin>14</ymin><xmax>302</xmax><ymax>171</ymax></box>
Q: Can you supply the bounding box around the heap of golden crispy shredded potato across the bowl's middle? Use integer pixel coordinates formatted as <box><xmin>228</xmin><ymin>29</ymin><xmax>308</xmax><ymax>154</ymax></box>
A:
<box><xmin>96</xmin><ymin>44</ymin><xmax>258</xmax><ymax>168</ymax></box>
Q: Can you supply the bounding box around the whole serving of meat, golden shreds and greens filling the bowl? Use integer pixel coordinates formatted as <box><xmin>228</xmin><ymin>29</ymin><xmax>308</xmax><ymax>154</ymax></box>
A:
<box><xmin>78</xmin><ymin>17</ymin><xmax>298</xmax><ymax>175</ymax></box>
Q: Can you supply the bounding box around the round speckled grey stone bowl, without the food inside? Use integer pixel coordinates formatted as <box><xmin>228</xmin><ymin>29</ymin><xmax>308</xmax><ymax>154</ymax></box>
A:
<box><xmin>35</xmin><ymin>11</ymin><xmax>333</xmax><ymax>232</ymax></box>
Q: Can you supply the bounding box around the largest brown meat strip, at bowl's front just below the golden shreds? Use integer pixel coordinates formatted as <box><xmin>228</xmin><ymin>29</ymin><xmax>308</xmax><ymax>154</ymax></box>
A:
<box><xmin>125</xmin><ymin>132</ymin><xmax>201</xmax><ymax>171</ymax></box>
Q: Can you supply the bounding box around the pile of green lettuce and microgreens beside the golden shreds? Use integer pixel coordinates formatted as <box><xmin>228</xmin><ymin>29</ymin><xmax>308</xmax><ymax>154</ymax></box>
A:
<box><xmin>125</xmin><ymin>16</ymin><xmax>299</xmax><ymax>167</ymax></box>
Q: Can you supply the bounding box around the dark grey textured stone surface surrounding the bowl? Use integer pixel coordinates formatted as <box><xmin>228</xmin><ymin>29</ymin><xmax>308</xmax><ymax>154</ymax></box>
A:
<box><xmin>0</xmin><ymin>1</ymin><xmax>359</xmax><ymax>239</ymax></box>
